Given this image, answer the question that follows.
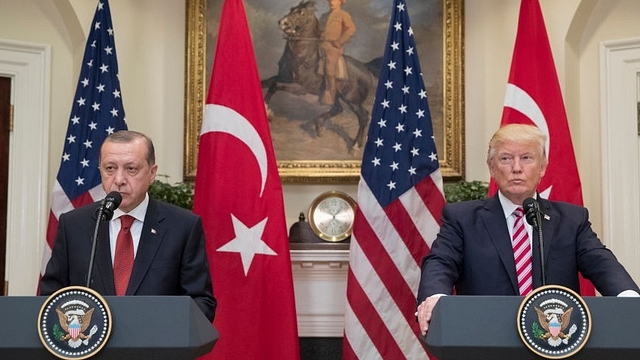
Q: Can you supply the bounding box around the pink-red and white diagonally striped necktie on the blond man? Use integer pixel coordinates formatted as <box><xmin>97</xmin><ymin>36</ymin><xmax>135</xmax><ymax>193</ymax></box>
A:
<box><xmin>511</xmin><ymin>207</ymin><xmax>533</xmax><ymax>295</ymax></box>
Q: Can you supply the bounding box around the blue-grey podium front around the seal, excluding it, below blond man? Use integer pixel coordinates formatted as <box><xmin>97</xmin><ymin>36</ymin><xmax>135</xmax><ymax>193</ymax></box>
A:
<box><xmin>425</xmin><ymin>296</ymin><xmax>640</xmax><ymax>360</ymax></box>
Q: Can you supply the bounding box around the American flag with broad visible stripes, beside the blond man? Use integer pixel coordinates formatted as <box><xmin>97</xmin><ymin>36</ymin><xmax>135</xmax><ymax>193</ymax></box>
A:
<box><xmin>343</xmin><ymin>0</ymin><xmax>445</xmax><ymax>359</ymax></box>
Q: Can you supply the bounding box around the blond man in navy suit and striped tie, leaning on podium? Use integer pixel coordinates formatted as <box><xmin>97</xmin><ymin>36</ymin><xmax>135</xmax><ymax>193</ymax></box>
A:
<box><xmin>417</xmin><ymin>124</ymin><xmax>640</xmax><ymax>335</ymax></box>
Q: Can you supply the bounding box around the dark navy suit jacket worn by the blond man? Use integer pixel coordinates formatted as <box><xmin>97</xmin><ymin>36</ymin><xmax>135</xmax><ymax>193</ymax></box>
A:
<box><xmin>417</xmin><ymin>194</ymin><xmax>640</xmax><ymax>303</ymax></box>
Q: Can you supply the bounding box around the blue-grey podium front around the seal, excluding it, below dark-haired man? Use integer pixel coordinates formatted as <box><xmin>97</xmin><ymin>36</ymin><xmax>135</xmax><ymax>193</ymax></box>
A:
<box><xmin>0</xmin><ymin>296</ymin><xmax>218</xmax><ymax>360</ymax></box>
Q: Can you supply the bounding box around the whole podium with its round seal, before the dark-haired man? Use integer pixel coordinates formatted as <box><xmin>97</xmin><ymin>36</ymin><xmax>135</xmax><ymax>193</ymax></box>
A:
<box><xmin>0</xmin><ymin>286</ymin><xmax>218</xmax><ymax>360</ymax></box>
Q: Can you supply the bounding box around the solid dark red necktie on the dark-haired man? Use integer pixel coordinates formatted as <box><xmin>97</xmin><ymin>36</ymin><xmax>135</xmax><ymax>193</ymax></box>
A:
<box><xmin>113</xmin><ymin>215</ymin><xmax>135</xmax><ymax>296</ymax></box>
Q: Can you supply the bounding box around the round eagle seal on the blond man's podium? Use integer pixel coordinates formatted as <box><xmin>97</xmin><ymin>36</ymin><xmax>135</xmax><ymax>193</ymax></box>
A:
<box><xmin>517</xmin><ymin>285</ymin><xmax>591</xmax><ymax>359</ymax></box>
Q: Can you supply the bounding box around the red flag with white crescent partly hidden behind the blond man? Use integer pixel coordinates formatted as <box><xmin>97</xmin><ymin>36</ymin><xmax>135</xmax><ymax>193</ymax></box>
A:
<box><xmin>489</xmin><ymin>0</ymin><xmax>595</xmax><ymax>296</ymax></box>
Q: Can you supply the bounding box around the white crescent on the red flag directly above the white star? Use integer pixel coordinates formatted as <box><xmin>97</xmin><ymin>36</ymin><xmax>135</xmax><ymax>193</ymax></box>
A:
<box><xmin>200</xmin><ymin>104</ymin><xmax>267</xmax><ymax>196</ymax></box>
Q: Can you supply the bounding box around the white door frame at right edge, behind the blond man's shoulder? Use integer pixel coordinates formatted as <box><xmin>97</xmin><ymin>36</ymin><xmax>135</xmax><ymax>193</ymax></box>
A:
<box><xmin>600</xmin><ymin>38</ymin><xmax>640</xmax><ymax>280</ymax></box>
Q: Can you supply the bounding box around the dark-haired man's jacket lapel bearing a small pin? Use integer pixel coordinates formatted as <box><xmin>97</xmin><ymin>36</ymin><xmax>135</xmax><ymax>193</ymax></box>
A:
<box><xmin>127</xmin><ymin>199</ymin><xmax>164</xmax><ymax>295</ymax></box>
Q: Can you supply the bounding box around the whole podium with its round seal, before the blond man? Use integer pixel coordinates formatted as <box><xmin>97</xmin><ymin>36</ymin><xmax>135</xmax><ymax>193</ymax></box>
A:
<box><xmin>424</xmin><ymin>286</ymin><xmax>640</xmax><ymax>360</ymax></box>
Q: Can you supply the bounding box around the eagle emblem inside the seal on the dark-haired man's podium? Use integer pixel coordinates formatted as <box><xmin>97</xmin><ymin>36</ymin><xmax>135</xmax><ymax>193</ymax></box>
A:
<box><xmin>56</xmin><ymin>307</ymin><xmax>98</xmax><ymax>349</ymax></box>
